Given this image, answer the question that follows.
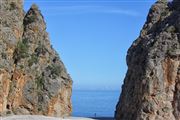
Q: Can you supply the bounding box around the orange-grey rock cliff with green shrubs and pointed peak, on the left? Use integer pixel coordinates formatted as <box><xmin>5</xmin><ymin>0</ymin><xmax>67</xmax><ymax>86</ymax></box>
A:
<box><xmin>0</xmin><ymin>0</ymin><xmax>72</xmax><ymax>116</ymax></box>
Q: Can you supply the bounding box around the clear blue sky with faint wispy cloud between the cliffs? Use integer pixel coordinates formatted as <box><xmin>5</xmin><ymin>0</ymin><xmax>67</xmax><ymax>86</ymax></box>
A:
<box><xmin>24</xmin><ymin>0</ymin><xmax>155</xmax><ymax>90</ymax></box>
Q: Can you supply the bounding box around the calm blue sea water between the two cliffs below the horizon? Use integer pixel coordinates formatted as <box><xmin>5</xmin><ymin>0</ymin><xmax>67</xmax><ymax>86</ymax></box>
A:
<box><xmin>72</xmin><ymin>90</ymin><xmax>120</xmax><ymax>117</ymax></box>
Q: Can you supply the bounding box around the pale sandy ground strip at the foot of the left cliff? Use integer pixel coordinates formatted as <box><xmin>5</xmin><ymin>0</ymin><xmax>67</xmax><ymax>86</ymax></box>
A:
<box><xmin>0</xmin><ymin>115</ymin><xmax>95</xmax><ymax>120</ymax></box>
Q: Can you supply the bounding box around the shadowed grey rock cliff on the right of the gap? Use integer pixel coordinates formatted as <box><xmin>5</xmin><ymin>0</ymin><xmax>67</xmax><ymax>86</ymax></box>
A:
<box><xmin>115</xmin><ymin>0</ymin><xmax>180</xmax><ymax>120</ymax></box>
